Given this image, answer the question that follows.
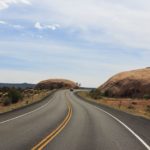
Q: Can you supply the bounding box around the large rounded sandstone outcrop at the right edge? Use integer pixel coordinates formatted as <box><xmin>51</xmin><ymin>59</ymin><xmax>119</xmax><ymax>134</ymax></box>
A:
<box><xmin>98</xmin><ymin>67</ymin><xmax>150</xmax><ymax>98</ymax></box>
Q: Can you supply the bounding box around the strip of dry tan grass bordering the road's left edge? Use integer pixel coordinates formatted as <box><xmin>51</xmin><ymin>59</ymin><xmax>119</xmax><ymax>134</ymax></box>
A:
<box><xmin>0</xmin><ymin>90</ymin><xmax>54</xmax><ymax>114</ymax></box>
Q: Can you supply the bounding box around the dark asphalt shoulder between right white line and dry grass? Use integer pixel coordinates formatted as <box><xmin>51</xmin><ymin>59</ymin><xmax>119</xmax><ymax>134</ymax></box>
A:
<box><xmin>74</xmin><ymin>92</ymin><xmax>150</xmax><ymax>145</ymax></box>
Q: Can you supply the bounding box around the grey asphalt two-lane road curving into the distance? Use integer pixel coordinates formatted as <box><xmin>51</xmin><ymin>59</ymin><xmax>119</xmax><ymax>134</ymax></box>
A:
<box><xmin>0</xmin><ymin>90</ymin><xmax>150</xmax><ymax>150</ymax></box>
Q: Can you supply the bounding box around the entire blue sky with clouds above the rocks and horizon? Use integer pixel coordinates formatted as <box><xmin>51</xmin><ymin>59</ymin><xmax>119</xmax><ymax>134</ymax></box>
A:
<box><xmin>0</xmin><ymin>0</ymin><xmax>150</xmax><ymax>87</ymax></box>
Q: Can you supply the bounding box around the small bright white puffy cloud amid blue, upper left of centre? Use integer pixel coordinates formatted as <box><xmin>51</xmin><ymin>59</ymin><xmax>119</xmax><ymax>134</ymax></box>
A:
<box><xmin>34</xmin><ymin>22</ymin><xmax>60</xmax><ymax>30</ymax></box>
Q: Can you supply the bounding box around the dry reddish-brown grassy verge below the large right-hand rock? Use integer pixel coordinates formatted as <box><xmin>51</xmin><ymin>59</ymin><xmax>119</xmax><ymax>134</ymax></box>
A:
<box><xmin>77</xmin><ymin>91</ymin><xmax>150</xmax><ymax>119</ymax></box>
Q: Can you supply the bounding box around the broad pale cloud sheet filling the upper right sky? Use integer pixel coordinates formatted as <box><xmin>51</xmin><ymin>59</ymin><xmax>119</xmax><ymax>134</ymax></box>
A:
<box><xmin>23</xmin><ymin>0</ymin><xmax>150</xmax><ymax>49</ymax></box>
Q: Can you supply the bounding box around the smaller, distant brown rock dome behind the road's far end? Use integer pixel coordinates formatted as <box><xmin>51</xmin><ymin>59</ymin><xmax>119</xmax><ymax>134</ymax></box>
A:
<box><xmin>35</xmin><ymin>79</ymin><xmax>77</xmax><ymax>90</ymax></box>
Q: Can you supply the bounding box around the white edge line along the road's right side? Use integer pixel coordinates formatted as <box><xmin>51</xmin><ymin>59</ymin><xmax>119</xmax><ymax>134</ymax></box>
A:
<box><xmin>94</xmin><ymin>106</ymin><xmax>150</xmax><ymax>150</ymax></box>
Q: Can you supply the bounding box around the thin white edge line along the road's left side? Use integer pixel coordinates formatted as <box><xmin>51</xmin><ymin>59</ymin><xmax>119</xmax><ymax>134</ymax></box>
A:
<box><xmin>0</xmin><ymin>94</ymin><xmax>54</xmax><ymax>125</ymax></box>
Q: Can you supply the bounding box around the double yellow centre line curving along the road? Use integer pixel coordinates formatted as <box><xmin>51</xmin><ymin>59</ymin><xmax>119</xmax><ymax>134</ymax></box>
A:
<box><xmin>32</xmin><ymin>96</ymin><xmax>72</xmax><ymax>150</ymax></box>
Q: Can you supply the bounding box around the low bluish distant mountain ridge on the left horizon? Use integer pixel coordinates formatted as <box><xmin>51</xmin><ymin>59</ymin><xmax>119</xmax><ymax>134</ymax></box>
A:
<box><xmin>0</xmin><ymin>83</ymin><xmax>35</xmax><ymax>89</ymax></box>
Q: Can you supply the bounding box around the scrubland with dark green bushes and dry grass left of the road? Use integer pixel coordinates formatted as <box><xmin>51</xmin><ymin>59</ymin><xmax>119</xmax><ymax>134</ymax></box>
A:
<box><xmin>0</xmin><ymin>87</ymin><xmax>52</xmax><ymax>113</ymax></box>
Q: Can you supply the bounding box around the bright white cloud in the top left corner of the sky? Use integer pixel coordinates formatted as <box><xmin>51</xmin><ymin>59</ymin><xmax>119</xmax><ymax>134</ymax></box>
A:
<box><xmin>0</xmin><ymin>0</ymin><xmax>31</xmax><ymax>10</ymax></box>
